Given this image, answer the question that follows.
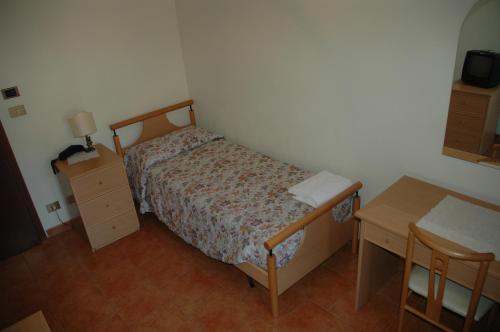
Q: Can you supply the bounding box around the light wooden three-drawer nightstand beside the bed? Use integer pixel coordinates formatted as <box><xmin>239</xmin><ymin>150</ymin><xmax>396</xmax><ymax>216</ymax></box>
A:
<box><xmin>56</xmin><ymin>144</ymin><xmax>139</xmax><ymax>251</ymax></box>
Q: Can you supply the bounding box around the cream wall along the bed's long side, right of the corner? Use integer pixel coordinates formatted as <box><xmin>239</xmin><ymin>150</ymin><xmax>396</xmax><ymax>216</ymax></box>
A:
<box><xmin>176</xmin><ymin>0</ymin><xmax>500</xmax><ymax>204</ymax></box>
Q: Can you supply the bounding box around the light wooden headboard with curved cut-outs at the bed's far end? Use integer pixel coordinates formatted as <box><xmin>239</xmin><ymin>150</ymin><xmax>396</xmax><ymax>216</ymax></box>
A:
<box><xmin>109</xmin><ymin>99</ymin><xmax>196</xmax><ymax>157</ymax></box>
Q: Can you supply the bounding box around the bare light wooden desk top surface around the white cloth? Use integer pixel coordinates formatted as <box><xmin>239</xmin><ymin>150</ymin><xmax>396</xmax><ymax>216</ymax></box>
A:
<box><xmin>356</xmin><ymin>176</ymin><xmax>500</xmax><ymax>276</ymax></box>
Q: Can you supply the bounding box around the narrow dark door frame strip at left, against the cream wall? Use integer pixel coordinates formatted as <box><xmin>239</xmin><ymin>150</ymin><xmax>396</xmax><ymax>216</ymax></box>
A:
<box><xmin>0</xmin><ymin>121</ymin><xmax>47</xmax><ymax>242</ymax></box>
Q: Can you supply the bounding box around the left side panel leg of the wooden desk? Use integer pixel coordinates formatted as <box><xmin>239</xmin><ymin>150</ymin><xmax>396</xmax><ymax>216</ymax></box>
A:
<box><xmin>355</xmin><ymin>221</ymin><xmax>400</xmax><ymax>310</ymax></box>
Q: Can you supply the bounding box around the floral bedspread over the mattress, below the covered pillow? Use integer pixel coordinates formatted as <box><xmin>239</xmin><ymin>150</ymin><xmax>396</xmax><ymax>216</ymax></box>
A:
<box><xmin>137</xmin><ymin>140</ymin><xmax>352</xmax><ymax>269</ymax></box>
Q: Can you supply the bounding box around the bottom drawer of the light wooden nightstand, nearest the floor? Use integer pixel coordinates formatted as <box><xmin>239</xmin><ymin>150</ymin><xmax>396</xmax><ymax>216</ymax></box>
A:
<box><xmin>86</xmin><ymin>210</ymin><xmax>139</xmax><ymax>250</ymax></box>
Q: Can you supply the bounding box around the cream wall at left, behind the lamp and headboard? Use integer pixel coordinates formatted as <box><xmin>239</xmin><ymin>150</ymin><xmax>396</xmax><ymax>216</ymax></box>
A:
<box><xmin>0</xmin><ymin>0</ymin><xmax>188</xmax><ymax>229</ymax></box>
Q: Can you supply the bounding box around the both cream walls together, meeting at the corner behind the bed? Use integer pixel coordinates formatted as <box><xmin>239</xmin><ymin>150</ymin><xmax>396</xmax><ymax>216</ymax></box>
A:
<box><xmin>0</xmin><ymin>0</ymin><xmax>500</xmax><ymax>228</ymax></box>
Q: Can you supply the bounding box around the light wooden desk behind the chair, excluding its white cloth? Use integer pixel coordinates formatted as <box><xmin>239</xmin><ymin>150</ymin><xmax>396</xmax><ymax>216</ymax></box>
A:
<box><xmin>356</xmin><ymin>176</ymin><xmax>500</xmax><ymax>309</ymax></box>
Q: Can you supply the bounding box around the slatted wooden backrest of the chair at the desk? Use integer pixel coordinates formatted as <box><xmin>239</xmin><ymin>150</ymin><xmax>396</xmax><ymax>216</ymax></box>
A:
<box><xmin>400</xmin><ymin>223</ymin><xmax>495</xmax><ymax>331</ymax></box>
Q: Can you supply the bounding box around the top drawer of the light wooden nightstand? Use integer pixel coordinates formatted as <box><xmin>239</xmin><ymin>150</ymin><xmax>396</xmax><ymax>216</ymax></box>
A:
<box><xmin>71</xmin><ymin>163</ymin><xmax>128</xmax><ymax>204</ymax></box>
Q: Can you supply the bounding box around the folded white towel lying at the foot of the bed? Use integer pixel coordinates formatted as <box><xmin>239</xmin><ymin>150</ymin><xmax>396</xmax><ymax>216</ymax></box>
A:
<box><xmin>288</xmin><ymin>171</ymin><xmax>352</xmax><ymax>208</ymax></box>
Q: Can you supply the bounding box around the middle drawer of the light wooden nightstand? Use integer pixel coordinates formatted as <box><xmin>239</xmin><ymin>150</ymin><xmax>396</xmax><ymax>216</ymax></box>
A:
<box><xmin>79</xmin><ymin>186</ymin><xmax>134</xmax><ymax>226</ymax></box>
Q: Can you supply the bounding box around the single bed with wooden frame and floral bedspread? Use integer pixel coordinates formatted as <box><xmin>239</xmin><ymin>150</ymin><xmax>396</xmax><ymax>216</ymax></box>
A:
<box><xmin>110</xmin><ymin>100</ymin><xmax>361</xmax><ymax>316</ymax></box>
